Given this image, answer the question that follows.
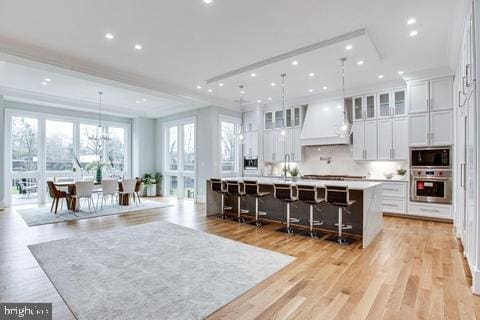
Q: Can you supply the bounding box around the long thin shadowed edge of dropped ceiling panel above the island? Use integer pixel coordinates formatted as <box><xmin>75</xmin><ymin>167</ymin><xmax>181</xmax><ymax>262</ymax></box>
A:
<box><xmin>207</xmin><ymin>28</ymin><xmax>367</xmax><ymax>84</ymax></box>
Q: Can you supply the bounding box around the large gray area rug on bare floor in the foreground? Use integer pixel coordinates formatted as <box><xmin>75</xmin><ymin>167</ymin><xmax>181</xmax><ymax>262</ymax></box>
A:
<box><xmin>29</xmin><ymin>221</ymin><xmax>295</xmax><ymax>320</ymax></box>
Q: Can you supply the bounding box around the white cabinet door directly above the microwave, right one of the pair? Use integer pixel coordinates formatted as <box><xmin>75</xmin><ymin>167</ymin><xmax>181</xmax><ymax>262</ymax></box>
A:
<box><xmin>430</xmin><ymin>110</ymin><xmax>453</xmax><ymax>146</ymax></box>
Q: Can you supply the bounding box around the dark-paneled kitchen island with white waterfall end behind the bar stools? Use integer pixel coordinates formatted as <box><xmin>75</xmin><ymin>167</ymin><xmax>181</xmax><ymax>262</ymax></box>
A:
<box><xmin>206</xmin><ymin>177</ymin><xmax>383</xmax><ymax>248</ymax></box>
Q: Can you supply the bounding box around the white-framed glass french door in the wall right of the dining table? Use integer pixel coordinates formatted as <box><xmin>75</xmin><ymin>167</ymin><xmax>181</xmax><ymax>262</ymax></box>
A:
<box><xmin>163</xmin><ymin>118</ymin><xmax>197</xmax><ymax>200</ymax></box>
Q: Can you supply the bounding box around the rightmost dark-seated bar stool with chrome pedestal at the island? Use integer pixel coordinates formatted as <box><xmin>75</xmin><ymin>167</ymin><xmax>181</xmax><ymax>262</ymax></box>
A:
<box><xmin>325</xmin><ymin>186</ymin><xmax>355</xmax><ymax>246</ymax></box>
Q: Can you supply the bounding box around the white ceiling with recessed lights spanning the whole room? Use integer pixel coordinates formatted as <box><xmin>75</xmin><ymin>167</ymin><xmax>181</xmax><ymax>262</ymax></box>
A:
<box><xmin>0</xmin><ymin>0</ymin><xmax>455</xmax><ymax>117</ymax></box>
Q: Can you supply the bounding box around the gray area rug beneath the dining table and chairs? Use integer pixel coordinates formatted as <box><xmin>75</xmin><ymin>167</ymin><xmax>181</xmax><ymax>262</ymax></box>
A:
<box><xmin>17</xmin><ymin>200</ymin><xmax>173</xmax><ymax>227</ymax></box>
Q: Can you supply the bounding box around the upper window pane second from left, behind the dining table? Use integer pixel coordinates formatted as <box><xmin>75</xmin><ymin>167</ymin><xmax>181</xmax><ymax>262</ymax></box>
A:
<box><xmin>45</xmin><ymin>120</ymin><xmax>73</xmax><ymax>171</ymax></box>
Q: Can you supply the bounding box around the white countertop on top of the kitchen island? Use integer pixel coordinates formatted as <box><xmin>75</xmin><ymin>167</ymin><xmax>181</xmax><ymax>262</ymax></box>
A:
<box><xmin>223</xmin><ymin>177</ymin><xmax>382</xmax><ymax>190</ymax></box>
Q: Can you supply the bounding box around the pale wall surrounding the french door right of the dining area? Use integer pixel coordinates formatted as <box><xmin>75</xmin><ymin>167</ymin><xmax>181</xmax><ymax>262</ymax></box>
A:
<box><xmin>155</xmin><ymin>106</ymin><xmax>241</xmax><ymax>202</ymax></box>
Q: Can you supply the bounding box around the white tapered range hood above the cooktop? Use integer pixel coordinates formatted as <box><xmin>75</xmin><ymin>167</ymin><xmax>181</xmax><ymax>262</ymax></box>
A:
<box><xmin>300</xmin><ymin>98</ymin><xmax>352</xmax><ymax>146</ymax></box>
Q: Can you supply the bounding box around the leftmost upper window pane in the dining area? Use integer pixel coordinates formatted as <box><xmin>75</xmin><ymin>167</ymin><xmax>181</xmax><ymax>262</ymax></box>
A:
<box><xmin>11</xmin><ymin>117</ymin><xmax>38</xmax><ymax>171</ymax></box>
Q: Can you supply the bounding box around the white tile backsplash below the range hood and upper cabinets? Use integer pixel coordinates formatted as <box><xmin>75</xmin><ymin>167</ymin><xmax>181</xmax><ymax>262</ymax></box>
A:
<box><xmin>270</xmin><ymin>145</ymin><xmax>408</xmax><ymax>178</ymax></box>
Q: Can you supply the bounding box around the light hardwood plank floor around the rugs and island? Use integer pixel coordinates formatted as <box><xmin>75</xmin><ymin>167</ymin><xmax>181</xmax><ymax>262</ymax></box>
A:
<box><xmin>0</xmin><ymin>200</ymin><xmax>480</xmax><ymax>319</ymax></box>
